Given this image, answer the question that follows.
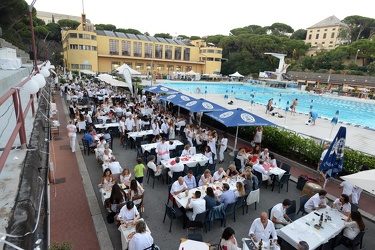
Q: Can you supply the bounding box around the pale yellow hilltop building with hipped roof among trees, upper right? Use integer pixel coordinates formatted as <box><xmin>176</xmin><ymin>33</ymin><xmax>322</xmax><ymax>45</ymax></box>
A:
<box><xmin>305</xmin><ymin>16</ymin><xmax>347</xmax><ymax>54</ymax></box>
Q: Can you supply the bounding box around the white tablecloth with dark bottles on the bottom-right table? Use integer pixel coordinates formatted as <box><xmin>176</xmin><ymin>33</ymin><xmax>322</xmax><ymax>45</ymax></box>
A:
<box><xmin>277</xmin><ymin>207</ymin><xmax>346</xmax><ymax>250</ymax></box>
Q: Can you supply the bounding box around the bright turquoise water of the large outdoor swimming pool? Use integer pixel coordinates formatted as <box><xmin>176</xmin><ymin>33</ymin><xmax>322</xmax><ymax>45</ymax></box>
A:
<box><xmin>163</xmin><ymin>82</ymin><xmax>375</xmax><ymax>128</ymax></box>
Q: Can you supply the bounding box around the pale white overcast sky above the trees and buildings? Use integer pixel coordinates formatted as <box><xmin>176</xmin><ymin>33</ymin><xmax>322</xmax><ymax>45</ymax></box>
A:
<box><xmin>33</xmin><ymin>0</ymin><xmax>375</xmax><ymax>37</ymax></box>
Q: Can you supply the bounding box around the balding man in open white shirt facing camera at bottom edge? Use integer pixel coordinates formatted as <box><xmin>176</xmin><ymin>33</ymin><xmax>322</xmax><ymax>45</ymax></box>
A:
<box><xmin>249</xmin><ymin>212</ymin><xmax>277</xmax><ymax>242</ymax></box>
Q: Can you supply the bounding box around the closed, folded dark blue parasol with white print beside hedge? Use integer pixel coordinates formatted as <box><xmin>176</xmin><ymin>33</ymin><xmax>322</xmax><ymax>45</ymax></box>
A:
<box><xmin>319</xmin><ymin>127</ymin><xmax>346</xmax><ymax>177</ymax></box>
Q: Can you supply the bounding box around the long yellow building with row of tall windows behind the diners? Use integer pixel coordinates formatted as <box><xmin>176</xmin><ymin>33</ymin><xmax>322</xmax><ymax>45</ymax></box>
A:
<box><xmin>62</xmin><ymin>17</ymin><xmax>223</xmax><ymax>76</ymax></box>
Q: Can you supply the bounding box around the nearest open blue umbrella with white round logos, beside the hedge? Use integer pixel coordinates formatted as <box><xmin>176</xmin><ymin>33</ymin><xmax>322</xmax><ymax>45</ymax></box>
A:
<box><xmin>206</xmin><ymin>108</ymin><xmax>277</xmax><ymax>148</ymax></box>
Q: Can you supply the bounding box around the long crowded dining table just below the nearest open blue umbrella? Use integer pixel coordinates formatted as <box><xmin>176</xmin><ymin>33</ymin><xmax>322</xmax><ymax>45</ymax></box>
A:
<box><xmin>173</xmin><ymin>176</ymin><xmax>245</xmax><ymax>208</ymax></box>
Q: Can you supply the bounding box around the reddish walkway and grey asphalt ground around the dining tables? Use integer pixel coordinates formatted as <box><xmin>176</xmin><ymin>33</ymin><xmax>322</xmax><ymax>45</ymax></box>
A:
<box><xmin>51</xmin><ymin>82</ymin><xmax>375</xmax><ymax>249</ymax></box>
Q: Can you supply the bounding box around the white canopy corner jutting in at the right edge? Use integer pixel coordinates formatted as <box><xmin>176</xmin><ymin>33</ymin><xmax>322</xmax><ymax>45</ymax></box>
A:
<box><xmin>341</xmin><ymin>169</ymin><xmax>375</xmax><ymax>194</ymax></box>
